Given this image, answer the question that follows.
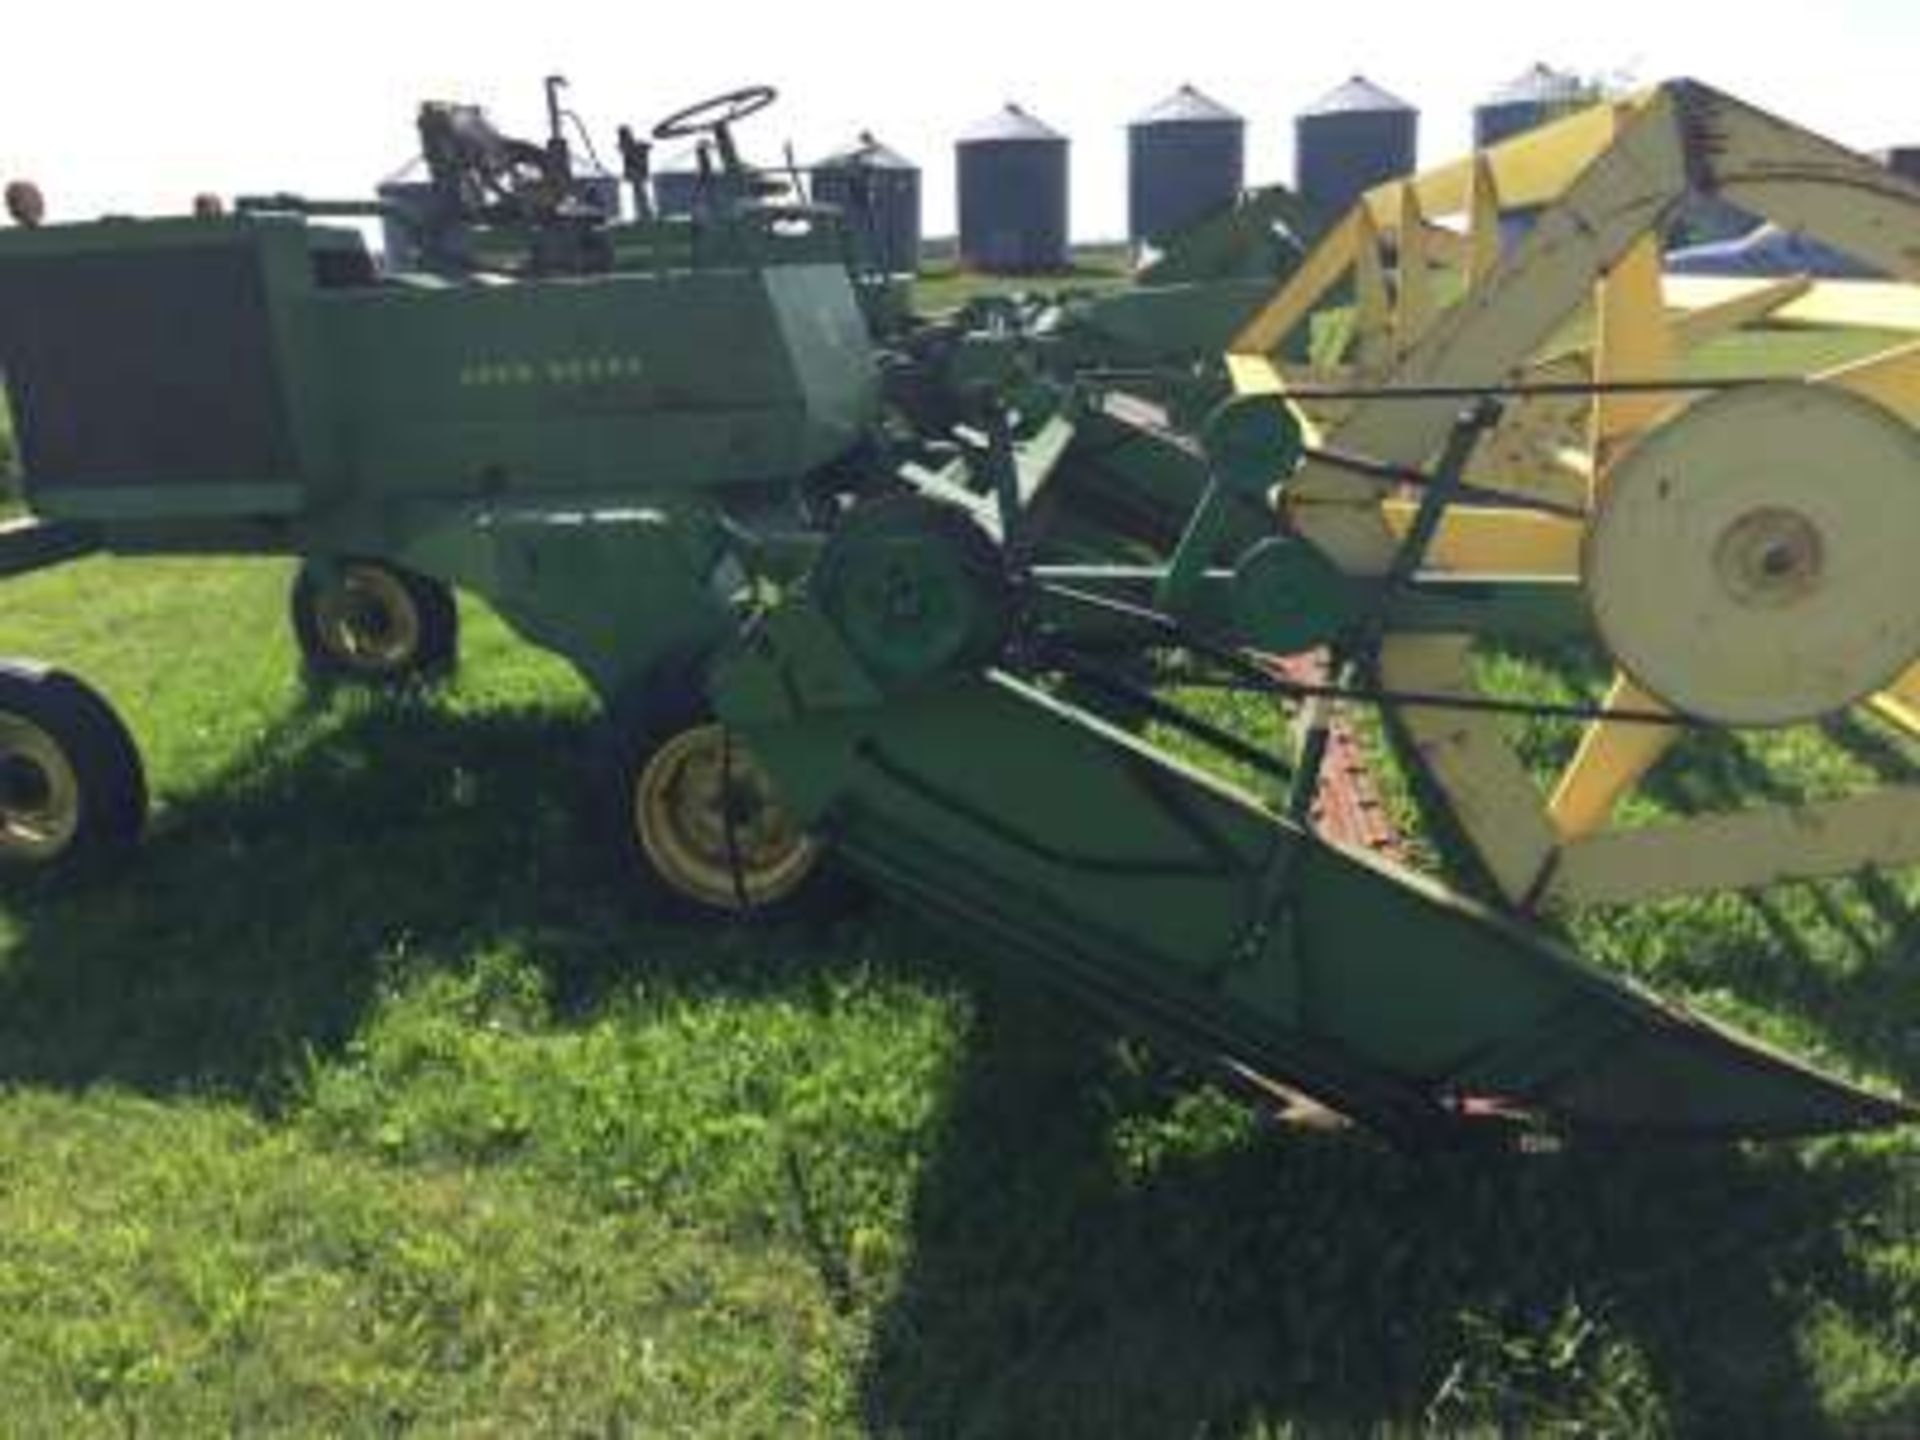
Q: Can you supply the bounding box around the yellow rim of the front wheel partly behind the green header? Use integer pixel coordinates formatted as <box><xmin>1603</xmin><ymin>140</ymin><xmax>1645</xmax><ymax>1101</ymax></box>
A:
<box><xmin>634</xmin><ymin>724</ymin><xmax>820</xmax><ymax>910</ymax></box>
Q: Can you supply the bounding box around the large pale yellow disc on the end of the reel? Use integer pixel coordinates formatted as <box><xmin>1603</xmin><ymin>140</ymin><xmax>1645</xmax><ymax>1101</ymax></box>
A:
<box><xmin>1584</xmin><ymin>384</ymin><xmax>1920</xmax><ymax>726</ymax></box>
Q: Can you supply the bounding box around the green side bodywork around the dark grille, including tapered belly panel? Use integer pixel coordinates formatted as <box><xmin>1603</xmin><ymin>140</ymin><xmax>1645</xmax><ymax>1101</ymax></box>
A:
<box><xmin>0</xmin><ymin>217</ymin><xmax>879</xmax><ymax>697</ymax></box>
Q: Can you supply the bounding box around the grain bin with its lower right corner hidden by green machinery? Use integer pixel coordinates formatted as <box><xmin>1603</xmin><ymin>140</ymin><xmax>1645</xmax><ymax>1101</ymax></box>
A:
<box><xmin>1127</xmin><ymin>84</ymin><xmax>1246</xmax><ymax>244</ymax></box>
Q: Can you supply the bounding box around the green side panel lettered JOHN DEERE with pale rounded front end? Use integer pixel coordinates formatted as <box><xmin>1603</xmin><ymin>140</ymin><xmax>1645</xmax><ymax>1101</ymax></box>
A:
<box><xmin>311</xmin><ymin>265</ymin><xmax>876</xmax><ymax>497</ymax></box>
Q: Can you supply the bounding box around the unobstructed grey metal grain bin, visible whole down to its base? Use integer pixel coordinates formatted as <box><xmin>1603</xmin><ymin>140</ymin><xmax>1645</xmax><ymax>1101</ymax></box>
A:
<box><xmin>954</xmin><ymin>104</ymin><xmax>1069</xmax><ymax>275</ymax></box>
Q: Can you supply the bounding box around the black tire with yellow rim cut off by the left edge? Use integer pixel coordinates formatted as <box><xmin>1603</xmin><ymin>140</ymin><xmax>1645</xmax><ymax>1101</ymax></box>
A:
<box><xmin>0</xmin><ymin>660</ymin><xmax>146</xmax><ymax>872</ymax></box>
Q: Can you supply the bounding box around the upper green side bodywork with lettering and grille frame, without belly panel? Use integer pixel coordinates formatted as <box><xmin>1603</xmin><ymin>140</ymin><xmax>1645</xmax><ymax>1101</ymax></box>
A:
<box><xmin>0</xmin><ymin>217</ymin><xmax>877</xmax><ymax>520</ymax></box>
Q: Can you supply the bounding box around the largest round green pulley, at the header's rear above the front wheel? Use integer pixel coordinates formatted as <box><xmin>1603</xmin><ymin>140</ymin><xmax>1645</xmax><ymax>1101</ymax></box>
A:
<box><xmin>808</xmin><ymin>495</ymin><xmax>1014</xmax><ymax>689</ymax></box>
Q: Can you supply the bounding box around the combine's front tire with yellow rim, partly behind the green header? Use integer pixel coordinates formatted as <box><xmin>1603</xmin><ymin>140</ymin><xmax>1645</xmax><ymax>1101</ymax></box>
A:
<box><xmin>595</xmin><ymin>666</ymin><xmax>858</xmax><ymax>924</ymax></box>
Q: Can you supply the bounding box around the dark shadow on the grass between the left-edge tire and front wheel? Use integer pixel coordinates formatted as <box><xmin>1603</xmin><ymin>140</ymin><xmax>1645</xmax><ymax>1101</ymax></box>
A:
<box><xmin>0</xmin><ymin>695</ymin><xmax>871</xmax><ymax>1108</ymax></box>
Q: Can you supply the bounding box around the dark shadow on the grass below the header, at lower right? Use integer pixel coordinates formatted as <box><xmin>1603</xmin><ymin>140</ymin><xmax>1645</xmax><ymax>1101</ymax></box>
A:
<box><xmin>862</xmin><ymin>998</ymin><xmax>1889</xmax><ymax>1436</ymax></box>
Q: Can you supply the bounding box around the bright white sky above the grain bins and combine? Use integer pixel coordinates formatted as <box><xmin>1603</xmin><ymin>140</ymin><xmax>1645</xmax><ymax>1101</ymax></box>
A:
<box><xmin>0</xmin><ymin>0</ymin><xmax>1920</xmax><ymax>240</ymax></box>
